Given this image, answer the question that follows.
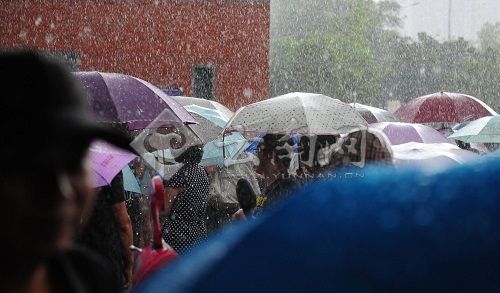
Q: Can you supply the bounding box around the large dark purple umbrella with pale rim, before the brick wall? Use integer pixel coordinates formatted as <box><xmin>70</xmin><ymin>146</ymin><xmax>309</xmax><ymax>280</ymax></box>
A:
<box><xmin>74</xmin><ymin>71</ymin><xmax>196</xmax><ymax>130</ymax></box>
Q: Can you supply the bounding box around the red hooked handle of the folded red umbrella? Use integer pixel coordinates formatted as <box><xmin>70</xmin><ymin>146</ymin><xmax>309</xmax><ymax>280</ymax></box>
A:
<box><xmin>150</xmin><ymin>176</ymin><xmax>165</xmax><ymax>250</ymax></box>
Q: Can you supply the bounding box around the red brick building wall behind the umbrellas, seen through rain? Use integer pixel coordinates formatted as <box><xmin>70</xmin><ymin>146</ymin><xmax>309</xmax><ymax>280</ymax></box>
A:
<box><xmin>0</xmin><ymin>0</ymin><xmax>270</xmax><ymax>109</ymax></box>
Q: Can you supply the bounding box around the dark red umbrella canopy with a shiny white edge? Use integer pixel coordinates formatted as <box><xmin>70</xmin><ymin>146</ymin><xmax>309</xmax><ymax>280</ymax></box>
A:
<box><xmin>394</xmin><ymin>92</ymin><xmax>497</xmax><ymax>123</ymax></box>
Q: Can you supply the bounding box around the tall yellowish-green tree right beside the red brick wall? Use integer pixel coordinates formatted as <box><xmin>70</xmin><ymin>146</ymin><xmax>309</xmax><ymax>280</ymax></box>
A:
<box><xmin>271</xmin><ymin>0</ymin><xmax>391</xmax><ymax>102</ymax></box>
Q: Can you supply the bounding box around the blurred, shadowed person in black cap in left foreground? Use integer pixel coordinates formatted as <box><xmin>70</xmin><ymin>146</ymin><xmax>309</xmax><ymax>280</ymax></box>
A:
<box><xmin>0</xmin><ymin>52</ymin><xmax>130</xmax><ymax>292</ymax></box>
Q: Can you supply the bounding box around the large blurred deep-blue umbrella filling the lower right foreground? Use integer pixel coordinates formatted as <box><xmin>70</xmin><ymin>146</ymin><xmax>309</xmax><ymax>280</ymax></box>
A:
<box><xmin>136</xmin><ymin>158</ymin><xmax>500</xmax><ymax>293</ymax></box>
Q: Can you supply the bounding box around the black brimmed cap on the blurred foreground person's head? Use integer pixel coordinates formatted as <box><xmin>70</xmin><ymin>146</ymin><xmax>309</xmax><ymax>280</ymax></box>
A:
<box><xmin>0</xmin><ymin>51</ymin><xmax>131</xmax><ymax>172</ymax></box>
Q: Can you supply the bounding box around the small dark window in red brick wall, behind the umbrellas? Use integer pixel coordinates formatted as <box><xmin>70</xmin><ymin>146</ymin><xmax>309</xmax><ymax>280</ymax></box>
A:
<box><xmin>193</xmin><ymin>64</ymin><xmax>215</xmax><ymax>100</ymax></box>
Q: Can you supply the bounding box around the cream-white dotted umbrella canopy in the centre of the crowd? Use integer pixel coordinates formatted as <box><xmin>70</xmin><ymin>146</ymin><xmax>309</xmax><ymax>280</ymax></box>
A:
<box><xmin>227</xmin><ymin>93</ymin><xmax>367</xmax><ymax>134</ymax></box>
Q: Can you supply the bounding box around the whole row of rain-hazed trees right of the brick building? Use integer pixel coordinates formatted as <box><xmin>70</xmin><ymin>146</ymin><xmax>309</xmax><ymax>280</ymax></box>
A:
<box><xmin>270</xmin><ymin>0</ymin><xmax>500</xmax><ymax>109</ymax></box>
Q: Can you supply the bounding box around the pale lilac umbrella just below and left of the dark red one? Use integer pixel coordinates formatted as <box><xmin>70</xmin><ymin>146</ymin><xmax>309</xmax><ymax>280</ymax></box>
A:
<box><xmin>369</xmin><ymin>122</ymin><xmax>451</xmax><ymax>145</ymax></box>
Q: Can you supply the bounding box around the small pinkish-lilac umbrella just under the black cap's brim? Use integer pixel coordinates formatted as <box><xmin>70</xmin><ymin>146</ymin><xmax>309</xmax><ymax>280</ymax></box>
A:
<box><xmin>89</xmin><ymin>141</ymin><xmax>136</xmax><ymax>187</ymax></box>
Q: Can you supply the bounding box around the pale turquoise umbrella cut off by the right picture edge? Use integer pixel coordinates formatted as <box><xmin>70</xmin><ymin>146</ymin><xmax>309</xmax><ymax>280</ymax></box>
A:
<box><xmin>448</xmin><ymin>115</ymin><xmax>500</xmax><ymax>143</ymax></box>
